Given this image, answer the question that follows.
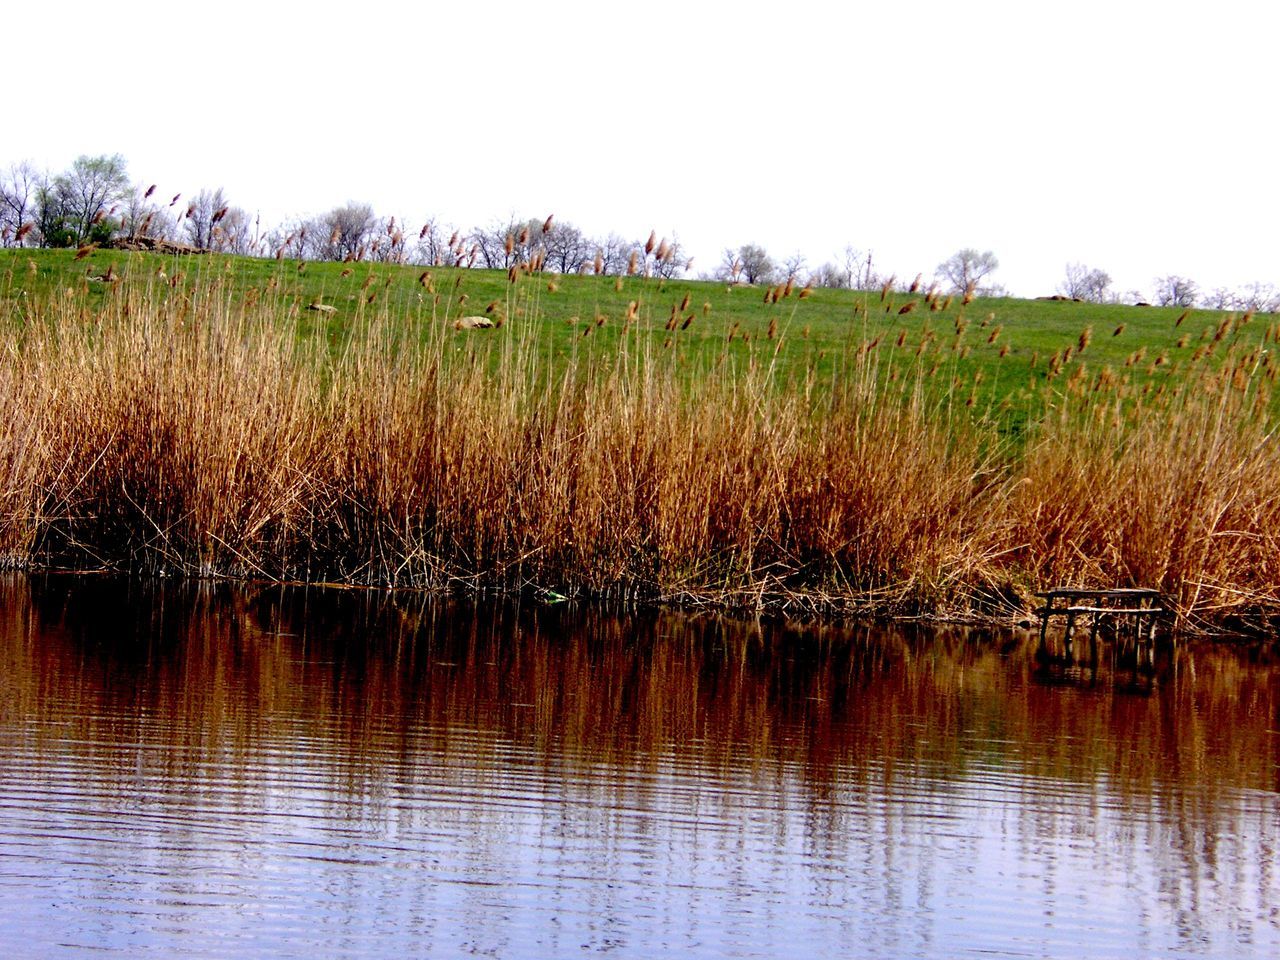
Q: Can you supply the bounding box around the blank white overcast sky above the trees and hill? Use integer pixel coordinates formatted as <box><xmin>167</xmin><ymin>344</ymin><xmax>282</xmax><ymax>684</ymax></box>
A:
<box><xmin>0</xmin><ymin>0</ymin><xmax>1280</xmax><ymax>296</ymax></box>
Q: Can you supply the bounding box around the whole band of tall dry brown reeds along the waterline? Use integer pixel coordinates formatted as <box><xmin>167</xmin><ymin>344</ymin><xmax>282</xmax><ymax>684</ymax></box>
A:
<box><xmin>0</xmin><ymin>282</ymin><xmax>1280</xmax><ymax>622</ymax></box>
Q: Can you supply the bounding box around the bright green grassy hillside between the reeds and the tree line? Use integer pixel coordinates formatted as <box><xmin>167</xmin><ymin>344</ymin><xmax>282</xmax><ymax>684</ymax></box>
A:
<box><xmin>0</xmin><ymin>250</ymin><xmax>1280</xmax><ymax>422</ymax></box>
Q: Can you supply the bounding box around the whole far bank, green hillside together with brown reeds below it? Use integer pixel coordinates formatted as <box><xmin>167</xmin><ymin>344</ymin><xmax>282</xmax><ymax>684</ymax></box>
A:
<box><xmin>0</xmin><ymin>244</ymin><xmax>1280</xmax><ymax>630</ymax></box>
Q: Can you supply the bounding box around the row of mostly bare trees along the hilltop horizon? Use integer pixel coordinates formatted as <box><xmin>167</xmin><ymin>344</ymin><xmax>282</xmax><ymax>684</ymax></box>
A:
<box><xmin>0</xmin><ymin>154</ymin><xmax>1280</xmax><ymax>312</ymax></box>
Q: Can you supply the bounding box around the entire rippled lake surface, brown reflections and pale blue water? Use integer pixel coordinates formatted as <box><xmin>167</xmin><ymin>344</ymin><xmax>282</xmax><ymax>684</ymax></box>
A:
<box><xmin>0</xmin><ymin>576</ymin><xmax>1280</xmax><ymax>960</ymax></box>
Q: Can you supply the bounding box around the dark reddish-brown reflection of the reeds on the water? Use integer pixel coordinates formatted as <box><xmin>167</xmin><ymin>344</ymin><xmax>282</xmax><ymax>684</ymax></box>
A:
<box><xmin>0</xmin><ymin>581</ymin><xmax>1280</xmax><ymax>820</ymax></box>
